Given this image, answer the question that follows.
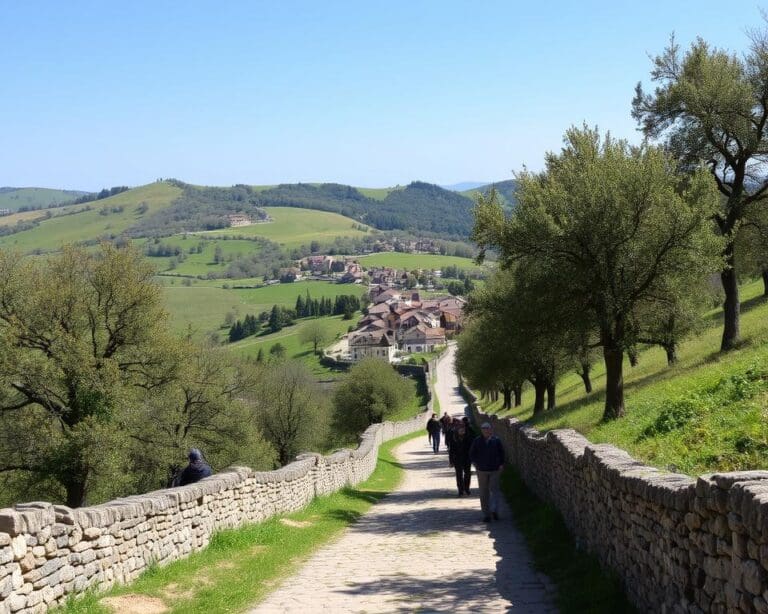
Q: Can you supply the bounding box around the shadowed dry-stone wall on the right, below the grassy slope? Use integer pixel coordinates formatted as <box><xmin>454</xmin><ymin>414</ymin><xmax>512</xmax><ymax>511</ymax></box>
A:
<box><xmin>465</xmin><ymin>390</ymin><xmax>768</xmax><ymax>612</ymax></box>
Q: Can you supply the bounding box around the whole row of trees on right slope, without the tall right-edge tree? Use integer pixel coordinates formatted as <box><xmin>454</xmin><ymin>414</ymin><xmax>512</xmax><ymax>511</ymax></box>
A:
<box><xmin>459</xmin><ymin>127</ymin><xmax>723</xmax><ymax>419</ymax></box>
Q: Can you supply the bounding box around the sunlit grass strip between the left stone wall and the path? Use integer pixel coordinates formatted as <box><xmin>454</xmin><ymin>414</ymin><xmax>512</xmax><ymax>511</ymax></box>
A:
<box><xmin>59</xmin><ymin>432</ymin><xmax>421</xmax><ymax>614</ymax></box>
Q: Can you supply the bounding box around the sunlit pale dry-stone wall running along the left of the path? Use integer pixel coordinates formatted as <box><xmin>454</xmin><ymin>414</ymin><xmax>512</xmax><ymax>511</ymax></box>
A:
<box><xmin>0</xmin><ymin>414</ymin><xmax>431</xmax><ymax>614</ymax></box>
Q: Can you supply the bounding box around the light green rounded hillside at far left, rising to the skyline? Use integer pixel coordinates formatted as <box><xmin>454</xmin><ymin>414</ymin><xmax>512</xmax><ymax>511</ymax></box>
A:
<box><xmin>0</xmin><ymin>182</ymin><xmax>181</xmax><ymax>253</ymax></box>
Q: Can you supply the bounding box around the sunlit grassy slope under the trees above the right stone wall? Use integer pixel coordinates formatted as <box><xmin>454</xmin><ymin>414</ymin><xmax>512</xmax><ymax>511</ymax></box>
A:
<box><xmin>481</xmin><ymin>282</ymin><xmax>768</xmax><ymax>474</ymax></box>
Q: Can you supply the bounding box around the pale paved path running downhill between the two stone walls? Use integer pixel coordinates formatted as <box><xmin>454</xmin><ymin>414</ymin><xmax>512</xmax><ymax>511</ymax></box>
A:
<box><xmin>252</xmin><ymin>348</ymin><xmax>557</xmax><ymax>614</ymax></box>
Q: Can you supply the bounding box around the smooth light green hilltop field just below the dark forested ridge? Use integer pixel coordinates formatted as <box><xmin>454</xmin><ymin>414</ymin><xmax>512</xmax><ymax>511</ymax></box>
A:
<box><xmin>199</xmin><ymin>207</ymin><xmax>366</xmax><ymax>248</ymax></box>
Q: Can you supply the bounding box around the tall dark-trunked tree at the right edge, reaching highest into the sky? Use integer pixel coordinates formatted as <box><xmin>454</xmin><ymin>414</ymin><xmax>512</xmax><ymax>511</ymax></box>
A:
<box><xmin>633</xmin><ymin>30</ymin><xmax>768</xmax><ymax>351</ymax></box>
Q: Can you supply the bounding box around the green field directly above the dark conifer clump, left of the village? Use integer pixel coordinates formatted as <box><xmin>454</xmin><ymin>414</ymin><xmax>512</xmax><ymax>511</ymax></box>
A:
<box><xmin>164</xmin><ymin>278</ymin><xmax>365</xmax><ymax>336</ymax></box>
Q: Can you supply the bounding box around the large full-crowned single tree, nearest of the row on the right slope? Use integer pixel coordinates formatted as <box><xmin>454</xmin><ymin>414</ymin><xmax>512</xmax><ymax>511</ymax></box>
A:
<box><xmin>474</xmin><ymin>126</ymin><xmax>720</xmax><ymax>419</ymax></box>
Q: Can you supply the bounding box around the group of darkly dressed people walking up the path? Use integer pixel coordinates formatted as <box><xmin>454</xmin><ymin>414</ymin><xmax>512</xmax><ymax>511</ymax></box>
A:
<box><xmin>427</xmin><ymin>412</ymin><xmax>504</xmax><ymax>522</ymax></box>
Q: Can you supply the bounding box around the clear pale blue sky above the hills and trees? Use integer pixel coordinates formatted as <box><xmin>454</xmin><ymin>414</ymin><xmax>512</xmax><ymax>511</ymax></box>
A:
<box><xmin>0</xmin><ymin>0</ymin><xmax>762</xmax><ymax>190</ymax></box>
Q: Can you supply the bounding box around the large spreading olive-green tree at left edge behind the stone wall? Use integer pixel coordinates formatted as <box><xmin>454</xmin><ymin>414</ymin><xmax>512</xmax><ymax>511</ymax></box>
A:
<box><xmin>0</xmin><ymin>244</ymin><xmax>178</xmax><ymax>507</ymax></box>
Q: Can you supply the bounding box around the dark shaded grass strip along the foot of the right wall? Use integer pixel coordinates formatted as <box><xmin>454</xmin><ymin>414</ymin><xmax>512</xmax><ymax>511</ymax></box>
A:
<box><xmin>501</xmin><ymin>467</ymin><xmax>635</xmax><ymax>614</ymax></box>
